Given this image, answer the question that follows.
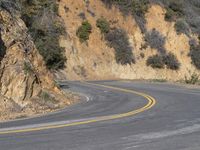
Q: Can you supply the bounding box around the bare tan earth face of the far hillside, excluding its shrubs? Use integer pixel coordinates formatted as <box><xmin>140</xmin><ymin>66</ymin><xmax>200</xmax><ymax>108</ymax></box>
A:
<box><xmin>59</xmin><ymin>0</ymin><xmax>199</xmax><ymax>80</ymax></box>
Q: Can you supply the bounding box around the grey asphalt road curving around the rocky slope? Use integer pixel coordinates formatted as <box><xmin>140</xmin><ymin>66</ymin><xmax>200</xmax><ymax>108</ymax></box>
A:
<box><xmin>0</xmin><ymin>81</ymin><xmax>200</xmax><ymax>150</ymax></box>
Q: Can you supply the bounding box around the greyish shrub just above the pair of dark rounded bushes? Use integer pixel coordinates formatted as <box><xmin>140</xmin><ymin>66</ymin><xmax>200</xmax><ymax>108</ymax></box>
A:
<box><xmin>145</xmin><ymin>29</ymin><xmax>166</xmax><ymax>54</ymax></box>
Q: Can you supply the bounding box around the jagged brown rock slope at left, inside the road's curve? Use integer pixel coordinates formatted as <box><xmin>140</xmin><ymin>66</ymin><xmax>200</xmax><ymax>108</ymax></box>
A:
<box><xmin>0</xmin><ymin>1</ymin><xmax>71</xmax><ymax>120</ymax></box>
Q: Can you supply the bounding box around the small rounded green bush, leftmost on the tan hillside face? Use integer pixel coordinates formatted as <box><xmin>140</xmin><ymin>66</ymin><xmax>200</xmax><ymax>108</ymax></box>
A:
<box><xmin>76</xmin><ymin>21</ymin><xmax>92</xmax><ymax>42</ymax></box>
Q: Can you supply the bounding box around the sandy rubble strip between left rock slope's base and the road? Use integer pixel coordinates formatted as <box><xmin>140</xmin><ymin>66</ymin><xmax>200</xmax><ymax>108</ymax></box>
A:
<box><xmin>0</xmin><ymin>91</ymin><xmax>80</xmax><ymax>122</ymax></box>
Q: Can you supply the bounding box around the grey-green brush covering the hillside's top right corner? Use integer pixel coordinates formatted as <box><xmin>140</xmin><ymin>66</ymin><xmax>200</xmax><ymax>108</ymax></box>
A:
<box><xmin>102</xmin><ymin>0</ymin><xmax>200</xmax><ymax>34</ymax></box>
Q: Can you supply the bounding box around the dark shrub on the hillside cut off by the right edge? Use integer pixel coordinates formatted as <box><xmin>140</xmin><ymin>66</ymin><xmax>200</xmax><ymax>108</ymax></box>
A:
<box><xmin>190</xmin><ymin>45</ymin><xmax>200</xmax><ymax>69</ymax></box>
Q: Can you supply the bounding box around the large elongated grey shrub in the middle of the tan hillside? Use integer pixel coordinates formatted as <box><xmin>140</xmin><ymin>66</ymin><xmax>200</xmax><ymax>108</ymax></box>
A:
<box><xmin>105</xmin><ymin>29</ymin><xmax>135</xmax><ymax>65</ymax></box>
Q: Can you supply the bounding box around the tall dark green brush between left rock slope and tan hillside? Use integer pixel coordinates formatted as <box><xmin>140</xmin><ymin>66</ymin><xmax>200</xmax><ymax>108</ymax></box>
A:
<box><xmin>18</xmin><ymin>0</ymin><xmax>66</xmax><ymax>70</ymax></box>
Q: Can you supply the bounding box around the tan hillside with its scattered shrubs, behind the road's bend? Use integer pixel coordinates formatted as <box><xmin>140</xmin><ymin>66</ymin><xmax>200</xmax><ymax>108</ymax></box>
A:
<box><xmin>55</xmin><ymin>0</ymin><xmax>200</xmax><ymax>80</ymax></box>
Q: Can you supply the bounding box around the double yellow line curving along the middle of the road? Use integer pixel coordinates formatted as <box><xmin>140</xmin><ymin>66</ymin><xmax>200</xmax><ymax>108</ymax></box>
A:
<box><xmin>0</xmin><ymin>82</ymin><xmax>156</xmax><ymax>135</ymax></box>
